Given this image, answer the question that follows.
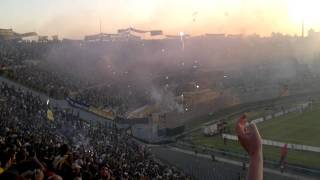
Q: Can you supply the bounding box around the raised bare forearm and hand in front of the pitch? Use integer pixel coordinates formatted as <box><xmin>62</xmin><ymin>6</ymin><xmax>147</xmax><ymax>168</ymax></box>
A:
<box><xmin>236</xmin><ymin>115</ymin><xmax>263</xmax><ymax>180</ymax></box>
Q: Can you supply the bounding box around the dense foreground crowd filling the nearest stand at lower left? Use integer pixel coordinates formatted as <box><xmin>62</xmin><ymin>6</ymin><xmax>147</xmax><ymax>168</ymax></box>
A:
<box><xmin>0</xmin><ymin>83</ymin><xmax>190</xmax><ymax>180</ymax></box>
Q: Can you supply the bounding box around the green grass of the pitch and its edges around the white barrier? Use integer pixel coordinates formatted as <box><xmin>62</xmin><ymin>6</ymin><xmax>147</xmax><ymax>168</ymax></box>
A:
<box><xmin>191</xmin><ymin>104</ymin><xmax>320</xmax><ymax>168</ymax></box>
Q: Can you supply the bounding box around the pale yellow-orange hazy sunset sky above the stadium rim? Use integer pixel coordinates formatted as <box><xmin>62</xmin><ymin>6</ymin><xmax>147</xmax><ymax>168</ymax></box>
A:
<box><xmin>0</xmin><ymin>0</ymin><xmax>320</xmax><ymax>38</ymax></box>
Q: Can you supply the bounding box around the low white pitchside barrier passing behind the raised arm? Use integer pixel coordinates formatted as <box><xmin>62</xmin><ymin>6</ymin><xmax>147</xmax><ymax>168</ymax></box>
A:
<box><xmin>222</xmin><ymin>134</ymin><xmax>320</xmax><ymax>152</ymax></box>
